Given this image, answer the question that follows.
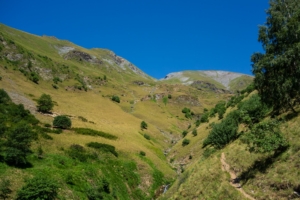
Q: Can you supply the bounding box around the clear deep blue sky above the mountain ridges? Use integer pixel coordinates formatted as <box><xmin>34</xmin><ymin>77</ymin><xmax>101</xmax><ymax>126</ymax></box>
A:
<box><xmin>0</xmin><ymin>0</ymin><xmax>269</xmax><ymax>78</ymax></box>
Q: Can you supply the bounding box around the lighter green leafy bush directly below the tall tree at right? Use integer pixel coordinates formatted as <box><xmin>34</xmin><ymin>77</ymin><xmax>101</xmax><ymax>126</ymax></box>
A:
<box><xmin>242</xmin><ymin>121</ymin><xmax>288</xmax><ymax>153</ymax></box>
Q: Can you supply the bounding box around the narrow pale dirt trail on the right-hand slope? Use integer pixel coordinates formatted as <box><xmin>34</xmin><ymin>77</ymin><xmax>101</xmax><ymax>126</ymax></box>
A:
<box><xmin>221</xmin><ymin>153</ymin><xmax>255</xmax><ymax>200</ymax></box>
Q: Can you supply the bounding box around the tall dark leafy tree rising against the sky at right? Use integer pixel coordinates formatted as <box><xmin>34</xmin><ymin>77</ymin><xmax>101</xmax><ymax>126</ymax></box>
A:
<box><xmin>251</xmin><ymin>0</ymin><xmax>300</xmax><ymax>111</ymax></box>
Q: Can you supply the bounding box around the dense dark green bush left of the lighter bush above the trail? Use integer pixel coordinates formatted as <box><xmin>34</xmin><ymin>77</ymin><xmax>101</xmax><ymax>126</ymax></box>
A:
<box><xmin>203</xmin><ymin>112</ymin><xmax>238</xmax><ymax>149</ymax></box>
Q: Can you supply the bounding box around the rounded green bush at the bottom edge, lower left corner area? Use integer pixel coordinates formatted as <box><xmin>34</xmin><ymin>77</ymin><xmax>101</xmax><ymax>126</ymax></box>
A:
<box><xmin>16</xmin><ymin>175</ymin><xmax>58</xmax><ymax>200</ymax></box>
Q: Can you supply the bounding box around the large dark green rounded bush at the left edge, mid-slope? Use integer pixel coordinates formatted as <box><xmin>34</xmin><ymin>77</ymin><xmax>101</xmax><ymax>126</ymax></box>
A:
<box><xmin>3</xmin><ymin>121</ymin><xmax>36</xmax><ymax>166</ymax></box>
